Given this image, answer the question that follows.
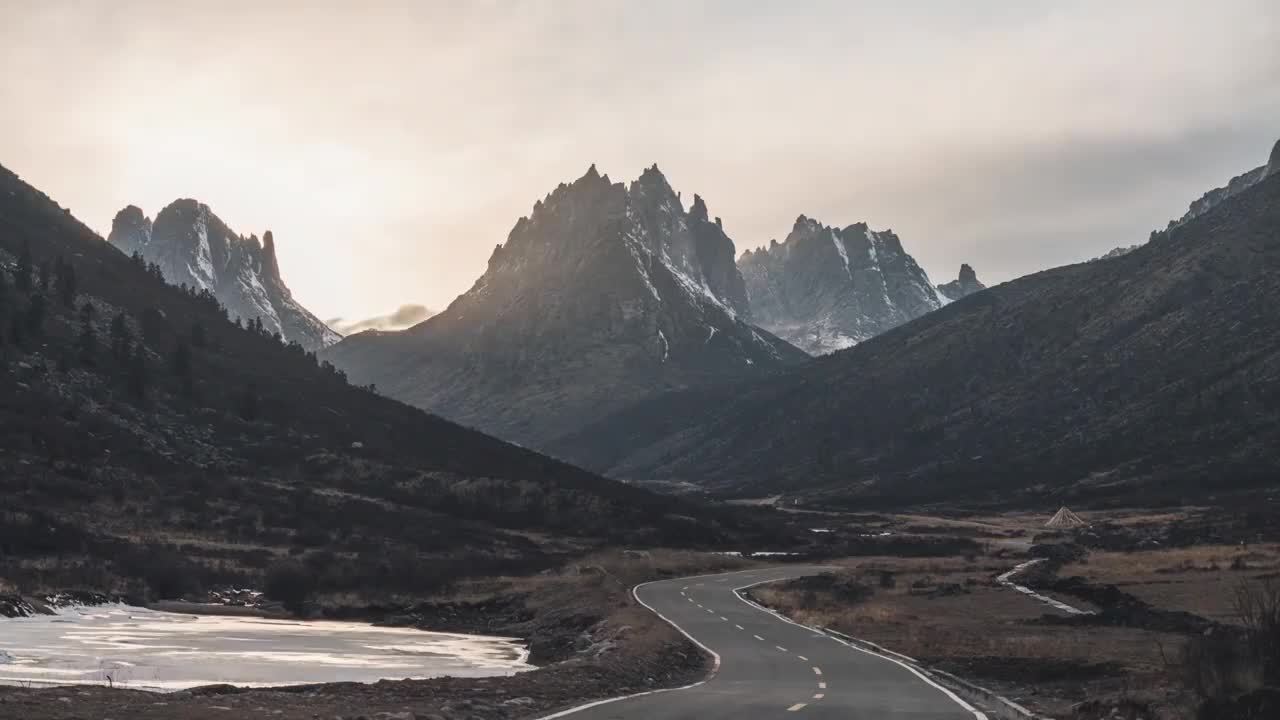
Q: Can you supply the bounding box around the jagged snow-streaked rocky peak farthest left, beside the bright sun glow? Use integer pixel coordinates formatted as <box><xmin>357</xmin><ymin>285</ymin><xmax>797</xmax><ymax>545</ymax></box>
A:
<box><xmin>108</xmin><ymin>199</ymin><xmax>342</xmax><ymax>350</ymax></box>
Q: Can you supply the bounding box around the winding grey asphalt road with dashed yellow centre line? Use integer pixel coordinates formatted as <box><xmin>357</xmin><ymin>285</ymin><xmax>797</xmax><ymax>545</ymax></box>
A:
<box><xmin>548</xmin><ymin>566</ymin><xmax>984</xmax><ymax>720</ymax></box>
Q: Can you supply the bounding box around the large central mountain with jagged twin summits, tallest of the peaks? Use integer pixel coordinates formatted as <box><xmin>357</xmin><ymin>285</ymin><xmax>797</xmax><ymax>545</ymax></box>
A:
<box><xmin>324</xmin><ymin>165</ymin><xmax>805</xmax><ymax>447</ymax></box>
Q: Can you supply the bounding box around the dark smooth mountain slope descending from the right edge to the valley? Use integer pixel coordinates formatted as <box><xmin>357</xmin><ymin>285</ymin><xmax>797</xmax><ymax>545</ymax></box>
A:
<box><xmin>563</xmin><ymin>149</ymin><xmax>1280</xmax><ymax>505</ymax></box>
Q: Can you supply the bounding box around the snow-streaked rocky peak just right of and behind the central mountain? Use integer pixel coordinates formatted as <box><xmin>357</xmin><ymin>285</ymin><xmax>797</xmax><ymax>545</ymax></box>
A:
<box><xmin>737</xmin><ymin>215</ymin><xmax>962</xmax><ymax>355</ymax></box>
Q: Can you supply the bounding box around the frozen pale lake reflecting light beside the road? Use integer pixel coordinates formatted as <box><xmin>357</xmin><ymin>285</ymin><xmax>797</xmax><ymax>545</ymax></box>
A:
<box><xmin>0</xmin><ymin>605</ymin><xmax>530</xmax><ymax>691</ymax></box>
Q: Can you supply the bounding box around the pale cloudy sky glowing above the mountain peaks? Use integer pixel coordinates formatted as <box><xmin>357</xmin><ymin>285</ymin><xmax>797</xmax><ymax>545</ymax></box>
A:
<box><xmin>0</xmin><ymin>0</ymin><xmax>1280</xmax><ymax>322</ymax></box>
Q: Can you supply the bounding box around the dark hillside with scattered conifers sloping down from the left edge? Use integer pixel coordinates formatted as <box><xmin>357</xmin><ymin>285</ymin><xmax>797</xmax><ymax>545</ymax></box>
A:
<box><xmin>0</xmin><ymin>168</ymin><xmax>768</xmax><ymax>596</ymax></box>
